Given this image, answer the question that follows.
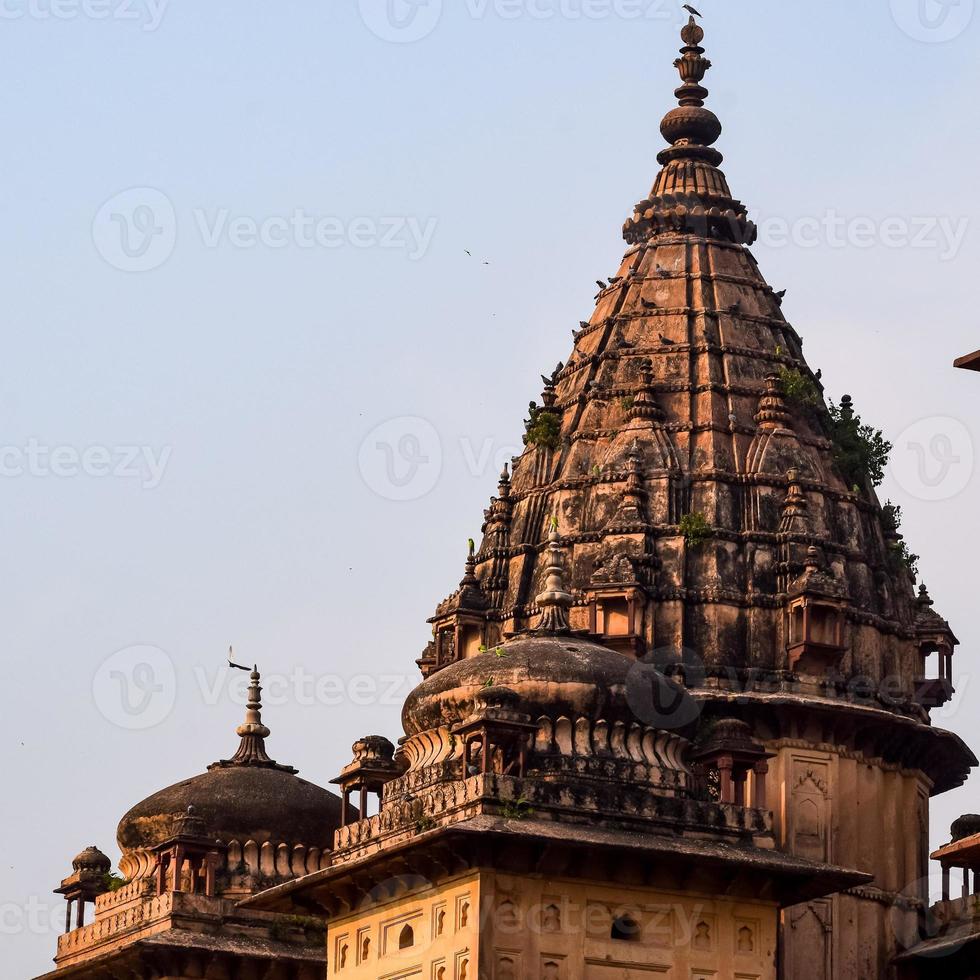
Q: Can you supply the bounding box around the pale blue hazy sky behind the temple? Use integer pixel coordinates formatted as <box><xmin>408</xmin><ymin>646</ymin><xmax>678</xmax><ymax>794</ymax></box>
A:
<box><xmin>0</xmin><ymin>0</ymin><xmax>980</xmax><ymax>977</ymax></box>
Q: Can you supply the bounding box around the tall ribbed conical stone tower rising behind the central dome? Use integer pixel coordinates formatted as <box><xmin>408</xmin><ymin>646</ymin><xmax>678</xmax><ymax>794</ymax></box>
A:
<box><xmin>419</xmin><ymin>18</ymin><xmax>976</xmax><ymax>980</ymax></box>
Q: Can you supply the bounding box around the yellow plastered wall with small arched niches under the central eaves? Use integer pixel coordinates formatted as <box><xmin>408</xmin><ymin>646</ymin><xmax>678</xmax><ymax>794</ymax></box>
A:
<box><xmin>327</xmin><ymin>872</ymin><xmax>777</xmax><ymax>980</ymax></box>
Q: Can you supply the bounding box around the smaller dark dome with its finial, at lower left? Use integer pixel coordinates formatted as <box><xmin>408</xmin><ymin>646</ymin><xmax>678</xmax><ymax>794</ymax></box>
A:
<box><xmin>116</xmin><ymin>670</ymin><xmax>341</xmax><ymax>855</ymax></box>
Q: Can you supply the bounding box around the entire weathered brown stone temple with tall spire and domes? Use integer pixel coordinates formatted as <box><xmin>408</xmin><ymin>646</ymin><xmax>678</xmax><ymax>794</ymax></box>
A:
<box><xmin>40</xmin><ymin>18</ymin><xmax>980</xmax><ymax>980</ymax></box>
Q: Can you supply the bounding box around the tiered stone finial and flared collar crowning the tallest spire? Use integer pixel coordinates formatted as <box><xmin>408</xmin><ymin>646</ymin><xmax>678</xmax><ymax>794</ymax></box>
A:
<box><xmin>623</xmin><ymin>17</ymin><xmax>756</xmax><ymax>245</ymax></box>
